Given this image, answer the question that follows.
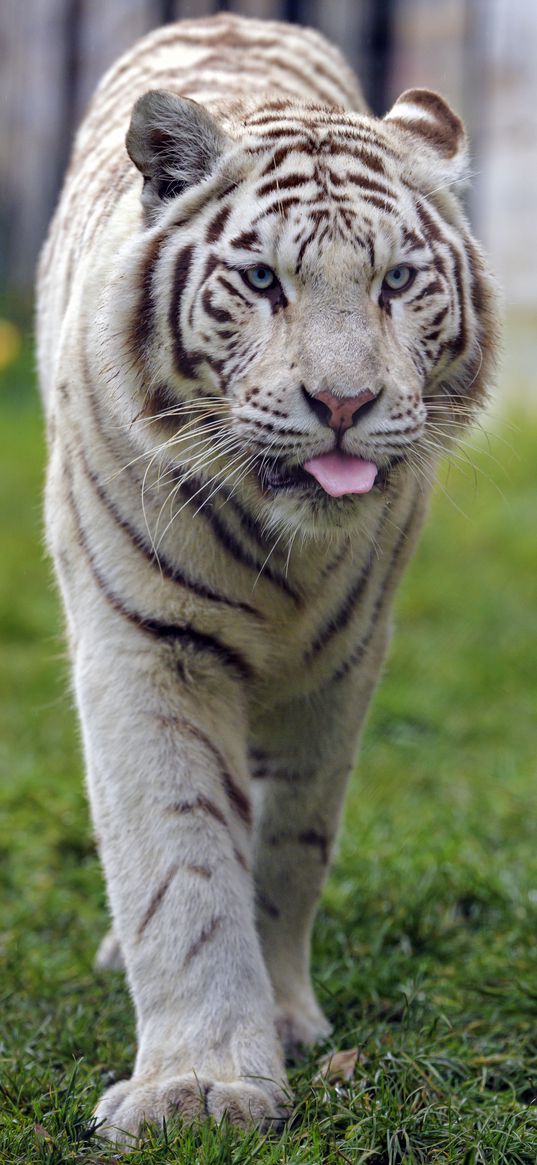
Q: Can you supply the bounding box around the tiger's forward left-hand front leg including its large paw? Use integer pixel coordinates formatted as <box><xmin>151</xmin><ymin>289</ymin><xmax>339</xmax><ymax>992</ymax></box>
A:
<box><xmin>76</xmin><ymin>616</ymin><xmax>285</xmax><ymax>1142</ymax></box>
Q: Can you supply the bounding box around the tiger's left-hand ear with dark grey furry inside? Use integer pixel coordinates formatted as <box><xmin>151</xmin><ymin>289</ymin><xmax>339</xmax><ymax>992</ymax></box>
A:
<box><xmin>126</xmin><ymin>89</ymin><xmax>229</xmax><ymax>221</ymax></box>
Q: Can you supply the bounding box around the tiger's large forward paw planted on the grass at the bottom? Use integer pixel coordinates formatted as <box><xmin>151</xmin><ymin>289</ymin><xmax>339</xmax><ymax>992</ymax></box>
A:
<box><xmin>94</xmin><ymin>1072</ymin><xmax>290</xmax><ymax>1145</ymax></box>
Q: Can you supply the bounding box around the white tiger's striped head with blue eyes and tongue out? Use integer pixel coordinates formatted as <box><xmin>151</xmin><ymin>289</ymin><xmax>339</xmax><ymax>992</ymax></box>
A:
<box><xmin>114</xmin><ymin>90</ymin><xmax>495</xmax><ymax>534</ymax></box>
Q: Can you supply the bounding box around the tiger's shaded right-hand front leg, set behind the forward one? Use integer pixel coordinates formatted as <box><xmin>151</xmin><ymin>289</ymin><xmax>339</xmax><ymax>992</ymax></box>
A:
<box><xmin>253</xmin><ymin>643</ymin><xmax>387</xmax><ymax>1057</ymax></box>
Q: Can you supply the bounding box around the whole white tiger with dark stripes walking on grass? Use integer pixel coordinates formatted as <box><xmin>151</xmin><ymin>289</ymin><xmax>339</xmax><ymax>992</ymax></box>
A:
<box><xmin>37</xmin><ymin>15</ymin><xmax>497</xmax><ymax>1144</ymax></box>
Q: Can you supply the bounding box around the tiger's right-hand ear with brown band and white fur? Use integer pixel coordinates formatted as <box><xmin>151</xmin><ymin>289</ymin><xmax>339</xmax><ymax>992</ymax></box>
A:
<box><xmin>384</xmin><ymin>89</ymin><xmax>468</xmax><ymax>188</ymax></box>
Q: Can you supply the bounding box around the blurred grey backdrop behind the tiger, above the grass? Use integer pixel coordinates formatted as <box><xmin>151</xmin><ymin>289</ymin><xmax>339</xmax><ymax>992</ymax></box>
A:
<box><xmin>0</xmin><ymin>0</ymin><xmax>537</xmax><ymax>405</ymax></box>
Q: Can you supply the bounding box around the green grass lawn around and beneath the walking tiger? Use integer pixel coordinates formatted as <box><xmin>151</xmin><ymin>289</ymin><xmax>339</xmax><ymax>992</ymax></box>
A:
<box><xmin>0</xmin><ymin>340</ymin><xmax>537</xmax><ymax>1165</ymax></box>
